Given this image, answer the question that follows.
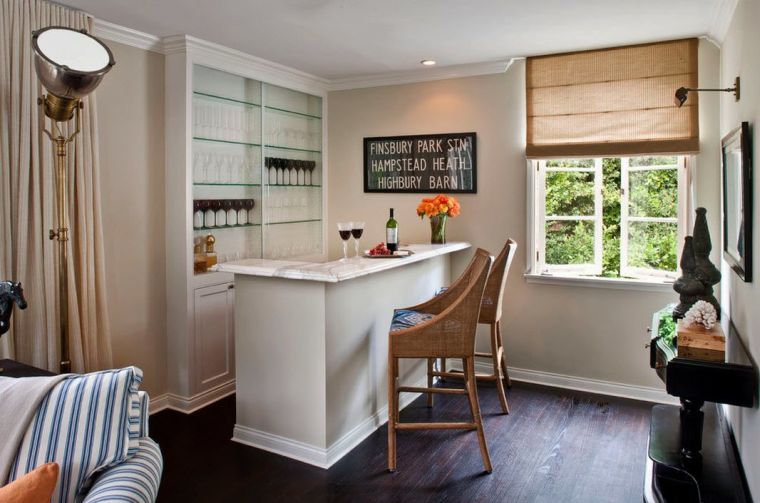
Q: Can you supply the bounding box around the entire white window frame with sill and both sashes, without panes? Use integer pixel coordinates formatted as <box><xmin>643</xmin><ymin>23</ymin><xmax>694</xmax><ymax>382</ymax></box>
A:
<box><xmin>525</xmin><ymin>155</ymin><xmax>693</xmax><ymax>282</ymax></box>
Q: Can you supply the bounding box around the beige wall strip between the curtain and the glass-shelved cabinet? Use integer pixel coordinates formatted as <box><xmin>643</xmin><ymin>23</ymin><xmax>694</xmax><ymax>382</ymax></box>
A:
<box><xmin>97</xmin><ymin>42</ymin><xmax>166</xmax><ymax>397</ymax></box>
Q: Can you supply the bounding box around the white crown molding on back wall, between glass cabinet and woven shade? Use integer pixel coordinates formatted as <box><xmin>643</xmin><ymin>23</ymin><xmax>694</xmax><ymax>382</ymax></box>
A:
<box><xmin>329</xmin><ymin>58</ymin><xmax>522</xmax><ymax>91</ymax></box>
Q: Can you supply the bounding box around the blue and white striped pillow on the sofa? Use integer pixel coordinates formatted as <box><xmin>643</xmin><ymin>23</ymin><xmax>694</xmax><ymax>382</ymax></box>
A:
<box><xmin>8</xmin><ymin>367</ymin><xmax>142</xmax><ymax>503</ymax></box>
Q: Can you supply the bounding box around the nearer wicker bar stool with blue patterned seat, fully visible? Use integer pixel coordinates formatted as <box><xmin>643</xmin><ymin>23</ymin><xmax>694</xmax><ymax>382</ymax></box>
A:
<box><xmin>388</xmin><ymin>249</ymin><xmax>493</xmax><ymax>473</ymax></box>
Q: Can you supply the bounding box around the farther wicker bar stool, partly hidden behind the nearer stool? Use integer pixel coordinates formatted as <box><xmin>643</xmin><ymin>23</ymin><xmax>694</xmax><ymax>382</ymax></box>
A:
<box><xmin>428</xmin><ymin>239</ymin><xmax>517</xmax><ymax>414</ymax></box>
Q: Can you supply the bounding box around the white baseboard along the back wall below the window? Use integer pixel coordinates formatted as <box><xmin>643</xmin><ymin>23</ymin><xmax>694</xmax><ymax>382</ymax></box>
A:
<box><xmin>458</xmin><ymin>361</ymin><xmax>679</xmax><ymax>405</ymax></box>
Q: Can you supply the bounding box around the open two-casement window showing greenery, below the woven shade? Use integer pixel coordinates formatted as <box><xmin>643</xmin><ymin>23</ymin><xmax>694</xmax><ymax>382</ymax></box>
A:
<box><xmin>531</xmin><ymin>155</ymin><xmax>687</xmax><ymax>280</ymax></box>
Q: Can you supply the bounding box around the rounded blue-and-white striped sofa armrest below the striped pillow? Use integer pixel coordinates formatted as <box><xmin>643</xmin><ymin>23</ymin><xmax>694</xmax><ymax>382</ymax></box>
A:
<box><xmin>82</xmin><ymin>437</ymin><xmax>164</xmax><ymax>503</ymax></box>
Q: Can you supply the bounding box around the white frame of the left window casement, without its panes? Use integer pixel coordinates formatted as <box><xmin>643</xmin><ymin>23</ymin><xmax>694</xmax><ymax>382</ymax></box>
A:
<box><xmin>533</xmin><ymin>158</ymin><xmax>604</xmax><ymax>276</ymax></box>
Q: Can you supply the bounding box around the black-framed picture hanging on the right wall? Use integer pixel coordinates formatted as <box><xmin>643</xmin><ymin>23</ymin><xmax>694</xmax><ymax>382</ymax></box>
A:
<box><xmin>721</xmin><ymin>122</ymin><xmax>753</xmax><ymax>283</ymax></box>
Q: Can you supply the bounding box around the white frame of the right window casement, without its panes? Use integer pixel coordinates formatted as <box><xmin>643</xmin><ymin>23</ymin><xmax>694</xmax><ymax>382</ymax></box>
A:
<box><xmin>620</xmin><ymin>156</ymin><xmax>689</xmax><ymax>279</ymax></box>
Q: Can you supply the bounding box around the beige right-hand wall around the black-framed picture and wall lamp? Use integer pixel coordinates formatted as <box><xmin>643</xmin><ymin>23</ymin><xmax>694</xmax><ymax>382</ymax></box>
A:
<box><xmin>720</xmin><ymin>0</ymin><xmax>760</xmax><ymax>500</ymax></box>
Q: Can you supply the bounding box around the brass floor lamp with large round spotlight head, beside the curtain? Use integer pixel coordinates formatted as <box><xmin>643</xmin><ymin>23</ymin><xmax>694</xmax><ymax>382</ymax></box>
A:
<box><xmin>32</xmin><ymin>26</ymin><xmax>114</xmax><ymax>373</ymax></box>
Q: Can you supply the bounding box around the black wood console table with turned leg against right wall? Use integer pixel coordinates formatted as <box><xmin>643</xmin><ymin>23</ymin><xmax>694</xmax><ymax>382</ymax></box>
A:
<box><xmin>644</xmin><ymin>314</ymin><xmax>757</xmax><ymax>503</ymax></box>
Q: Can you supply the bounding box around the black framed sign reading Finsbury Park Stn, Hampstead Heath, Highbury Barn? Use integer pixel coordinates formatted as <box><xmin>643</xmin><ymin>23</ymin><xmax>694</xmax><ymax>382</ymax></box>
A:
<box><xmin>364</xmin><ymin>133</ymin><xmax>477</xmax><ymax>194</ymax></box>
